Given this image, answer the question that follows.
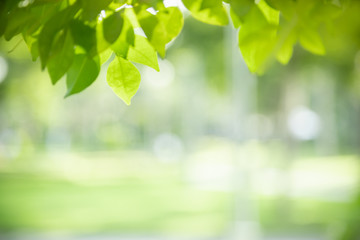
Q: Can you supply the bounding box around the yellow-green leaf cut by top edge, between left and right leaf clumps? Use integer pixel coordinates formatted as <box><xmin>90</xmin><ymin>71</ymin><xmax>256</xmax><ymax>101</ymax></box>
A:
<box><xmin>182</xmin><ymin>0</ymin><xmax>229</xmax><ymax>26</ymax></box>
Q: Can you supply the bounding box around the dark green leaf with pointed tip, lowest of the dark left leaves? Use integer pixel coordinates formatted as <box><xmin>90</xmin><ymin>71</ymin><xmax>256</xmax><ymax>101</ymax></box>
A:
<box><xmin>65</xmin><ymin>54</ymin><xmax>100</xmax><ymax>97</ymax></box>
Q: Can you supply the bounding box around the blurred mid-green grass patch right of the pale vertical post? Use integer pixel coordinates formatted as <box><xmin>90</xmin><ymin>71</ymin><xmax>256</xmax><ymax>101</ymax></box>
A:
<box><xmin>259</xmin><ymin>197</ymin><xmax>350</xmax><ymax>234</ymax></box>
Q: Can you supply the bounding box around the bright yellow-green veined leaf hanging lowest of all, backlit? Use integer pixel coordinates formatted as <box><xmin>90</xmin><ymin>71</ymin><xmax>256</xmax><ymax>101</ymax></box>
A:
<box><xmin>106</xmin><ymin>57</ymin><xmax>141</xmax><ymax>105</ymax></box>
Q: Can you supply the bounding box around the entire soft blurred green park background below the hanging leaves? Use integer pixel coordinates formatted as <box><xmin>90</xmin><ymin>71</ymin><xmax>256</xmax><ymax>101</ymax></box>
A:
<box><xmin>0</xmin><ymin>6</ymin><xmax>360</xmax><ymax>240</ymax></box>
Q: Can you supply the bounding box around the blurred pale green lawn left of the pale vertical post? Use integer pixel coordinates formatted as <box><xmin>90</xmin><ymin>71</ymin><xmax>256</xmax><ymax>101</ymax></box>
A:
<box><xmin>0</xmin><ymin>152</ymin><xmax>231</xmax><ymax>236</ymax></box>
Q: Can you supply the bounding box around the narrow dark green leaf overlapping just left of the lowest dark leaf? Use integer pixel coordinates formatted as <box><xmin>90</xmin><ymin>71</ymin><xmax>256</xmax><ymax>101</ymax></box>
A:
<box><xmin>47</xmin><ymin>32</ymin><xmax>74</xmax><ymax>84</ymax></box>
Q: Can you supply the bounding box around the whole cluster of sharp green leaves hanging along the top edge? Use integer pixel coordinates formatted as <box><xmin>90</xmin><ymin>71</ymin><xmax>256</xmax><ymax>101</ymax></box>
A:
<box><xmin>0</xmin><ymin>0</ymin><xmax>351</xmax><ymax>104</ymax></box>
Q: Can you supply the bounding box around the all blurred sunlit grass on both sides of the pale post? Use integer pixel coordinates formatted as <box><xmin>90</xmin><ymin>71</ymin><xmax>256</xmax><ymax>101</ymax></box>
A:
<box><xmin>0</xmin><ymin>145</ymin><xmax>359</xmax><ymax>237</ymax></box>
